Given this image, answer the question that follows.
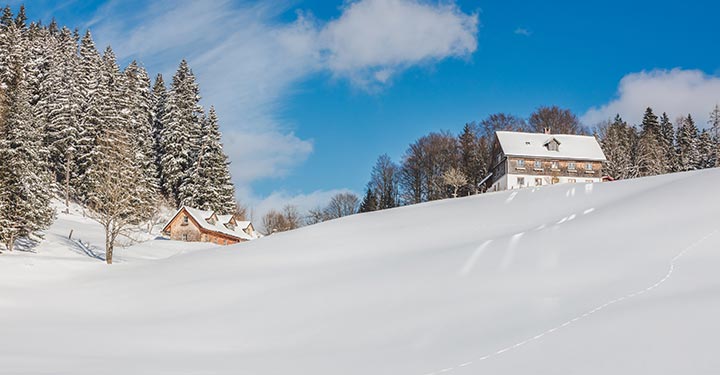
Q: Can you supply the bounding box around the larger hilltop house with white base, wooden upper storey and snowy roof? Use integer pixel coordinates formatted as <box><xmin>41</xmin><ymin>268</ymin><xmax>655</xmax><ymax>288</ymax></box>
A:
<box><xmin>488</xmin><ymin>130</ymin><xmax>606</xmax><ymax>191</ymax></box>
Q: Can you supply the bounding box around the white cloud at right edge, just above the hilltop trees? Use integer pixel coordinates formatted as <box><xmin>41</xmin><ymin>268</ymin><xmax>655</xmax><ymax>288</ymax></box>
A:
<box><xmin>581</xmin><ymin>68</ymin><xmax>720</xmax><ymax>127</ymax></box>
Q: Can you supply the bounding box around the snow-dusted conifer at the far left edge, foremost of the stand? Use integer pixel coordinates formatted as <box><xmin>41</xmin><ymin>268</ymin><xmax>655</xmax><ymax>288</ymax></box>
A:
<box><xmin>0</xmin><ymin>56</ymin><xmax>53</xmax><ymax>251</ymax></box>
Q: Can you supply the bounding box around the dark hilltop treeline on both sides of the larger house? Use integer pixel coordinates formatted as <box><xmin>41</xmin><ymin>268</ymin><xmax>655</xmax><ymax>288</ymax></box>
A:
<box><xmin>359</xmin><ymin>106</ymin><xmax>720</xmax><ymax>212</ymax></box>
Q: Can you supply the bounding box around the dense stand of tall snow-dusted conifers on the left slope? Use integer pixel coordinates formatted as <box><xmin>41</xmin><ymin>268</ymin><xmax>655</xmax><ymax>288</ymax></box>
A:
<box><xmin>0</xmin><ymin>7</ymin><xmax>235</xmax><ymax>256</ymax></box>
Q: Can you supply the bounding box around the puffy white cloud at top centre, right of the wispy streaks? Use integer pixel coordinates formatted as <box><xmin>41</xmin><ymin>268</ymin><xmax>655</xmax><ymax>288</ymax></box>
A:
<box><xmin>319</xmin><ymin>0</ymin><xmax>478</xmax><ymax>85</ymax></box>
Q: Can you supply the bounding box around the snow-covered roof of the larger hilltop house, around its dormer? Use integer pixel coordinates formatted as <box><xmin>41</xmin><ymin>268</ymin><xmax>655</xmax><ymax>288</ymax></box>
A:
<box><xmin>495</xmin><ymin>131</ymin><xmax>607</xmax><ymax>161</ymax></box>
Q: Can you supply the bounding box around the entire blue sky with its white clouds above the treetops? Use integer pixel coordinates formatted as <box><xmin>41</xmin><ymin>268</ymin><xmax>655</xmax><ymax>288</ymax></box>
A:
<box><xmin>15</xmin><ymin>0</ymin><xmax>720</xmax><ymax>216</ymax></box>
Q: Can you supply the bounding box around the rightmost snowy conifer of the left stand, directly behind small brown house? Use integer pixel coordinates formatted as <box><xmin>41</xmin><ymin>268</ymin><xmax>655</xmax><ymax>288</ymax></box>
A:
<box><xmin>180</xmin><ymin>107</ymin><xmax>236</xmax><ymax>214</ymax></box>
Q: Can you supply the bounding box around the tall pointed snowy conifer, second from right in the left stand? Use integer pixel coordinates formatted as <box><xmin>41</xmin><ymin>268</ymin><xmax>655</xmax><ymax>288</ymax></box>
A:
<box><xmin>160</xmin><ymin>60</ymin><xmax>203</xmax><ymax>206</ymax></box>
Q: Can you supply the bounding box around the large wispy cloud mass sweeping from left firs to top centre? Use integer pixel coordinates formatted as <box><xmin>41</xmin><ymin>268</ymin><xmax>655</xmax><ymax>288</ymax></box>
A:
<box><xmin>87</xmin><ymin>0</ymin><xmax>478</xmax><ymax>213</ymax></box>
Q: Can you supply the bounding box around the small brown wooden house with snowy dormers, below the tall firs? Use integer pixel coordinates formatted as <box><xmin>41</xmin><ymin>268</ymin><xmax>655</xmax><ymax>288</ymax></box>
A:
<box><xmin>163</xmin><ymin>207</ymin><xmax>260</xmax><ymax>245</ymax></box>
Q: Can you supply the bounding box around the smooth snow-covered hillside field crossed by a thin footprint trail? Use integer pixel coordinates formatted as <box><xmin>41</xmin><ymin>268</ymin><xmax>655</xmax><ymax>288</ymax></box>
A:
<box><xmin>0</xmin><ymin>170</ymin><xmax>720</xmax><ymax>375</ymax></box>
